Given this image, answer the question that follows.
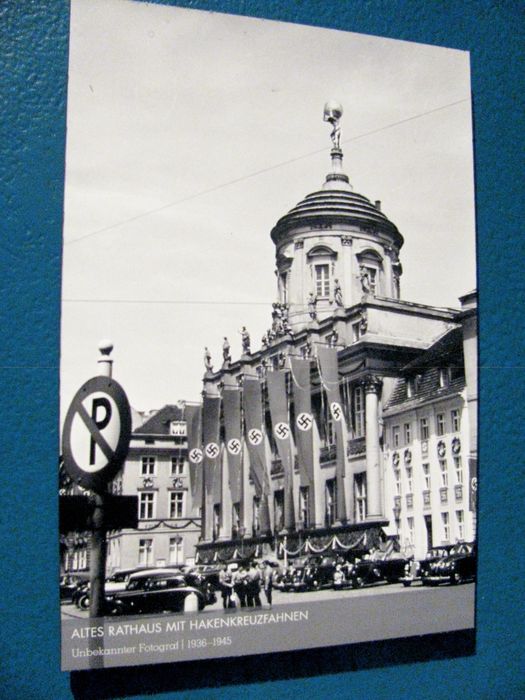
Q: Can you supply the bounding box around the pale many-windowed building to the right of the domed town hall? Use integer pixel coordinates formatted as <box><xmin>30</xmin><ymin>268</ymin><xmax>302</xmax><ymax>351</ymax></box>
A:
<box><xmin>383</xmin><ymin>295</ymin><xmax>477</xmax><ymax>559</ymax></box>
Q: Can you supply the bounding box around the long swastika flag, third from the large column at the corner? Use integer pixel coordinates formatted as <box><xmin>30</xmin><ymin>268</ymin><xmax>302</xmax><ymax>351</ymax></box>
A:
<box><xmin>266</xmin><ymin>370</ymin><xmax>295</xmax><ymax>531</ymax></box>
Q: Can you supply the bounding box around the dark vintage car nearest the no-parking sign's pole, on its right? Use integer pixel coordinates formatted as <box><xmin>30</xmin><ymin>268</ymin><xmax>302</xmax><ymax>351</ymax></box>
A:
<box><xmin>109</xmin><ymin>574</ymin><xmax>211</xmax><ymax>615</ymax></box>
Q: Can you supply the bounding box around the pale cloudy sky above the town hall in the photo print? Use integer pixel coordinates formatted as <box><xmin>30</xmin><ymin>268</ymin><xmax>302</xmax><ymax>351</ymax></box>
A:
<box><xmin>61</xmin><ymin>0</ymin><xmax>476</xmax><ymax>420</ymax></box>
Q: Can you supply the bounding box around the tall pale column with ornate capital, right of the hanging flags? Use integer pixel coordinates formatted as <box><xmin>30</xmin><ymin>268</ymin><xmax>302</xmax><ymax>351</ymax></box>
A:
<box><xmin>364</xmin><ymin>375</ymin><xmax>383</xmax><ymax>520</ymax></box>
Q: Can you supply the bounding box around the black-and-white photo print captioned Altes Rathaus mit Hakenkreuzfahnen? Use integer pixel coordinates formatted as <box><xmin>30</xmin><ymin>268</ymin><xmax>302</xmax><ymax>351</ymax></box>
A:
<box><xmin>57</xmin><ymin>0</ymin><xmax>478</xmax><ymax>670</ymax></box>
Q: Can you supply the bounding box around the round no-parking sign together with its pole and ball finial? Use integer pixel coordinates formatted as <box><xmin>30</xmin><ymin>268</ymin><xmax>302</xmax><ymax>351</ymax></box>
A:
<box><xmin>62</xmin><ymin>342</ymin><xmax>131</xmax><ymax>617</ymax></box>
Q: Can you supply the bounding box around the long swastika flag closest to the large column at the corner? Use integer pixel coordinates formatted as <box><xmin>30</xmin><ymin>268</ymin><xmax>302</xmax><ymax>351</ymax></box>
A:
<box><xmin>317</xmin><ymin>345</ymin><xmax>347</xmax><ymax>522</ymax></box>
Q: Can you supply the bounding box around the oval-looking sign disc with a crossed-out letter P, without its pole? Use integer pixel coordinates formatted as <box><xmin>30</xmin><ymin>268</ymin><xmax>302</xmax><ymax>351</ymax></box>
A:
<box><xmin>62</xmin><ymin>376</ymin><xmax>131</xmax><ymax>493</ymax></box>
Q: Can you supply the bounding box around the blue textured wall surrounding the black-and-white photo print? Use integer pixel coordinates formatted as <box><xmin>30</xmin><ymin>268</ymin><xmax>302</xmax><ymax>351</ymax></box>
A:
<box><xmin>0</xmin><ymin>0</ymin><xmax>525</xmax><ymax>700</ymax></box>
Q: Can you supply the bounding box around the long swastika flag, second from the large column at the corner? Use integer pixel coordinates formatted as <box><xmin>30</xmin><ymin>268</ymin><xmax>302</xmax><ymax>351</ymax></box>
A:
<box><xmin>290</xmin><ymin>358</ymin><xmax>314</xmax><ymax>490</ymax></box>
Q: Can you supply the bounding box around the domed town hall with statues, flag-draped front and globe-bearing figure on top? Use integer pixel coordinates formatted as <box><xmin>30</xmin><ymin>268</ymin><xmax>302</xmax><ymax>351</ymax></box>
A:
<box><xmin>193</xmin><ymin>103</ymin><xmax>475</xmax><ymax>562</ymax></box>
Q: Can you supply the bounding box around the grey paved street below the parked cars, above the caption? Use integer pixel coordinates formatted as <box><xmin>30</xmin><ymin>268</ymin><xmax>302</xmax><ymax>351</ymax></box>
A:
<box><xmin>61</xmin><ymin>583</ymin><xmax>474</xmax><ymax>620</ymax></box>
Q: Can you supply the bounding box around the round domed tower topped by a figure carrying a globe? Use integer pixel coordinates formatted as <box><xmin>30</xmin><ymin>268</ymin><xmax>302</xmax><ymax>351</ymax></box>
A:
<box><xmin>271</xmin><ymin>101</ymin><xmax>403</xmax><ymax>332</ymax></box>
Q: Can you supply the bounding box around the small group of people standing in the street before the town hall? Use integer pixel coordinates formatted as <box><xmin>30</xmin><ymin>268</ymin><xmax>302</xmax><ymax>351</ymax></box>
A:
<box><xmin>219</xmin><ymin>561</ymin><xmax>273</xmax><ymax>609</ymax></box>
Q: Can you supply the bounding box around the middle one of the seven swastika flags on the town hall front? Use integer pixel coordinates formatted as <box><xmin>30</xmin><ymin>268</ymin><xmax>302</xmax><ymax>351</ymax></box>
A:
<box><xmin>243</xmin><ymin>376</ymin><xmax>270</xmax><ymax>534</ymax></box>
